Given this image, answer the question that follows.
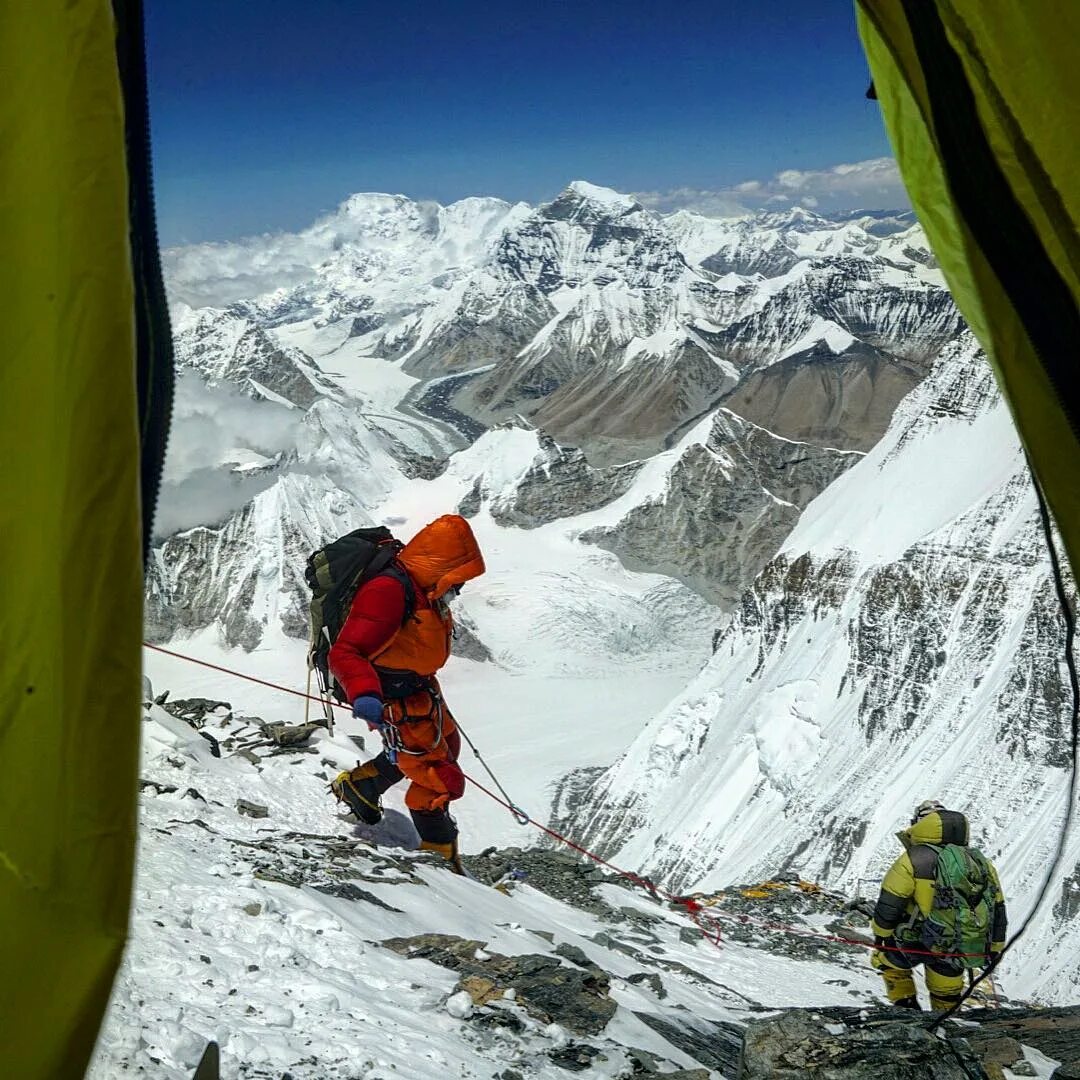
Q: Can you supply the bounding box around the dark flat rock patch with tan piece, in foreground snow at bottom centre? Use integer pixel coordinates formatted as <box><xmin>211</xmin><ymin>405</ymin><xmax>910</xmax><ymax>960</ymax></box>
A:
<box><xmin>382</xmin><ymin>934</ymin><xmax>616</xmax><ymax>1035</ymax></box>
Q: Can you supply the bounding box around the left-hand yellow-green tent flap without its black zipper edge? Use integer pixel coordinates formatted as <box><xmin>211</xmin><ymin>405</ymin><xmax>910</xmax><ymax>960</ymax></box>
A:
<box><xmin>0</xmin><ymin>0</ymin><xmax>141</xmax><ymax>1080</ymax></box>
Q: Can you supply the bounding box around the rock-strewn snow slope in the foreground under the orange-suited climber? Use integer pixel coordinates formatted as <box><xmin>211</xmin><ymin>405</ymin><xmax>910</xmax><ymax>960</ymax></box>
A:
<box><xmin>89</xmin><ymin>701</ymin><xmax>889</xmax><ymax>1080</ymax></box>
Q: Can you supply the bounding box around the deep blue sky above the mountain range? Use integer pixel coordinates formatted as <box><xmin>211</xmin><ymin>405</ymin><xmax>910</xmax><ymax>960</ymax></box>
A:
<box><xmin>147</xmin><ymin>0</ymin><xmax>903</xmax><ymax>244</ymax></box>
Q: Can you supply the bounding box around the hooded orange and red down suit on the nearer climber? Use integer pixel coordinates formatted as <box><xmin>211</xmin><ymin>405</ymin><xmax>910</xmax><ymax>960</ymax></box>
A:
<box><xmin>329</xmin><ymin>514</ymin><xmax>484</xmax><ymax>816</ymax></box>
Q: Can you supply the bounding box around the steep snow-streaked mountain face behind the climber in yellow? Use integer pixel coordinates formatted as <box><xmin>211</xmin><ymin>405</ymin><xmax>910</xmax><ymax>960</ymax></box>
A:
<box><xmin>556</xmin><ymin>336</ymin><xmax>1080</xmax><ymax>1001</ymax></box>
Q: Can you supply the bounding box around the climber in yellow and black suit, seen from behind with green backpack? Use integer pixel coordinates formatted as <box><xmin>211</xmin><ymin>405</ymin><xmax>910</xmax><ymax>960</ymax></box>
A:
<box><xmin>870</xmin><ymin>799</ymin><xmax>1007</xmax><ymax>1010</ymax></box>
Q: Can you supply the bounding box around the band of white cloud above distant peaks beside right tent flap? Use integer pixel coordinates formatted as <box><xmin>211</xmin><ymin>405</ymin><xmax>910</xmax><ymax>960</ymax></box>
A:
<box><xmin>637</xmin><ymin>158</ymin><xmax>910</xmax><ymax>217</ymax></box>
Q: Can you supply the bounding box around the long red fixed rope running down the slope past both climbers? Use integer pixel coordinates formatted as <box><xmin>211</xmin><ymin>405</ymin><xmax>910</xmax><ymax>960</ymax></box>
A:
<box><xmin>143</xmin><ymin>642</ymin><xmax>986</xmax><ymax>960</ymax></box>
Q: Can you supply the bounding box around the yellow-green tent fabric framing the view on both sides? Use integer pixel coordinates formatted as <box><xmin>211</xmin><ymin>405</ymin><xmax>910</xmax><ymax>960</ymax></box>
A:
<box><xmin>0</xmin><ymin>0</ymin><xmax>1080</xmax><ymax>1080</ymax></box>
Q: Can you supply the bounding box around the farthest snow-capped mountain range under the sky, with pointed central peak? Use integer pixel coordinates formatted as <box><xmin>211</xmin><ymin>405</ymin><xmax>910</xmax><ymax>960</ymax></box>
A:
<box><xmin>168</xmin><ymin>181</ymin><xmax>959</xmax><ymax>461</ymax></box>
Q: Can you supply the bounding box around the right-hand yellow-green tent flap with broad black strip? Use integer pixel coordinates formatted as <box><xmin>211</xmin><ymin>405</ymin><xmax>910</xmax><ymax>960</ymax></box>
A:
<box><xmin>856</xmin><ymin>0</ymin><xmax>1080</xmax><ymax>579</ymax></box>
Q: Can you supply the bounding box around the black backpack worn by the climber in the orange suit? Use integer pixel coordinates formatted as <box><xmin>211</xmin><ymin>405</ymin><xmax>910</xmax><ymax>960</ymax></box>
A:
<box><xmin>303</xmin><ymin>525</ymin><xmax>416</xmax><ymax>704</ymax></box>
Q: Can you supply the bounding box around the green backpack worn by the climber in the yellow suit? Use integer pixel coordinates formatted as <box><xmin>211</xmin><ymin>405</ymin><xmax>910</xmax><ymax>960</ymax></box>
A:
<box><xmin>919</xmin><ymin>843</ymin><xmax>996</xmax><ymax>968</ymax></box>
